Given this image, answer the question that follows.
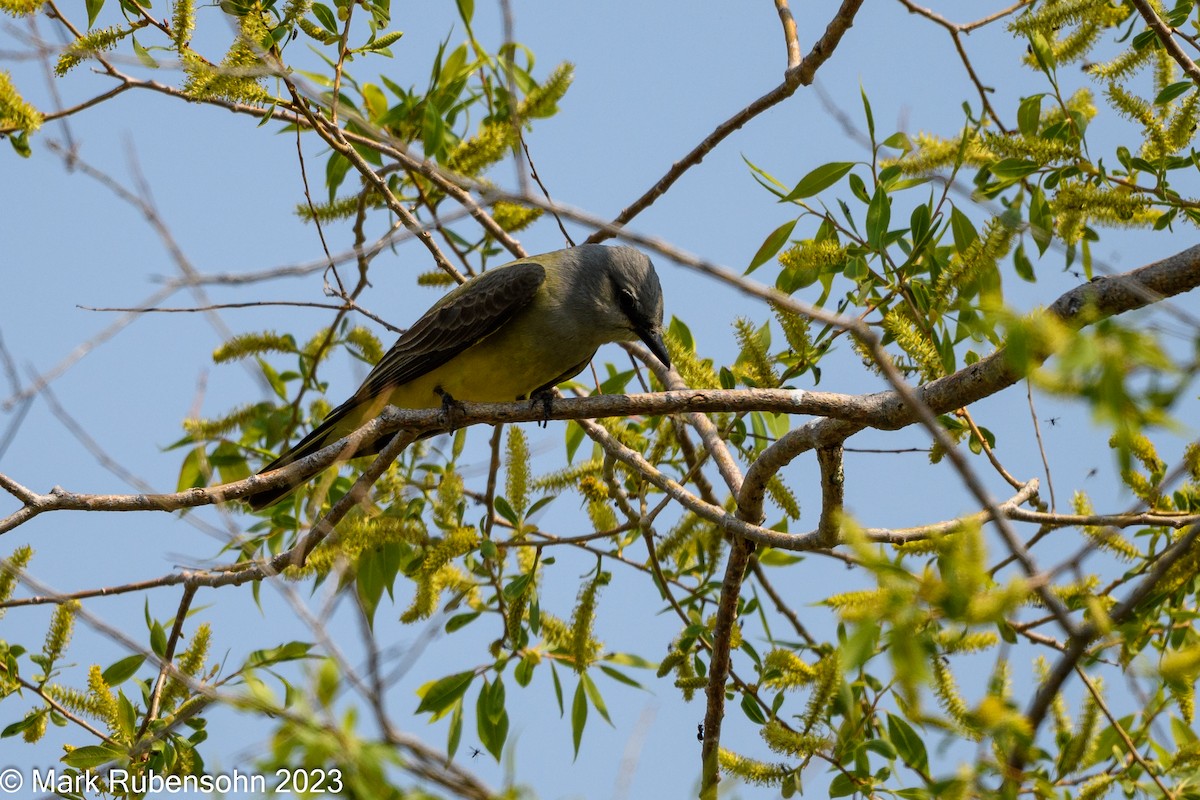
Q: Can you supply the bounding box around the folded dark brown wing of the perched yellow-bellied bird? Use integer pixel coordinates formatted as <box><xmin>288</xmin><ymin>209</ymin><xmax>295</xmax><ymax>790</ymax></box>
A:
<box><xmin>354</xmin><ymin>261</ymin><xmax>546</xmax><ymax>401</ymax></box>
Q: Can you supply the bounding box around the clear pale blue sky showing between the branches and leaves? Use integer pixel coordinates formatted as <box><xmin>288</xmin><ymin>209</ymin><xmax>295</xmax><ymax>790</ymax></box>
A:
<box><xmin>0</xmin><ymin>0</ymin><xmax>1194</xmax><ymax>799</ymax></box>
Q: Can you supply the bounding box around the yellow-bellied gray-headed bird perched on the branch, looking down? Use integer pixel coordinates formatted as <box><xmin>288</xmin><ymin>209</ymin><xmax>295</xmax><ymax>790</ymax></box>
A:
<box><xmin>244</xmin><ymin>245</ymin><xmax>671</xmax><ymax>511</ymax></box>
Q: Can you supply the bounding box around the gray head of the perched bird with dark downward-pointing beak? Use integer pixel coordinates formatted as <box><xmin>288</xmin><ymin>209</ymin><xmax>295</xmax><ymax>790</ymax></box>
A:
<box><xmin>568</xmin><ymin>245</ymin><xmax>671</xmax><ymax>367</ymax></box>
